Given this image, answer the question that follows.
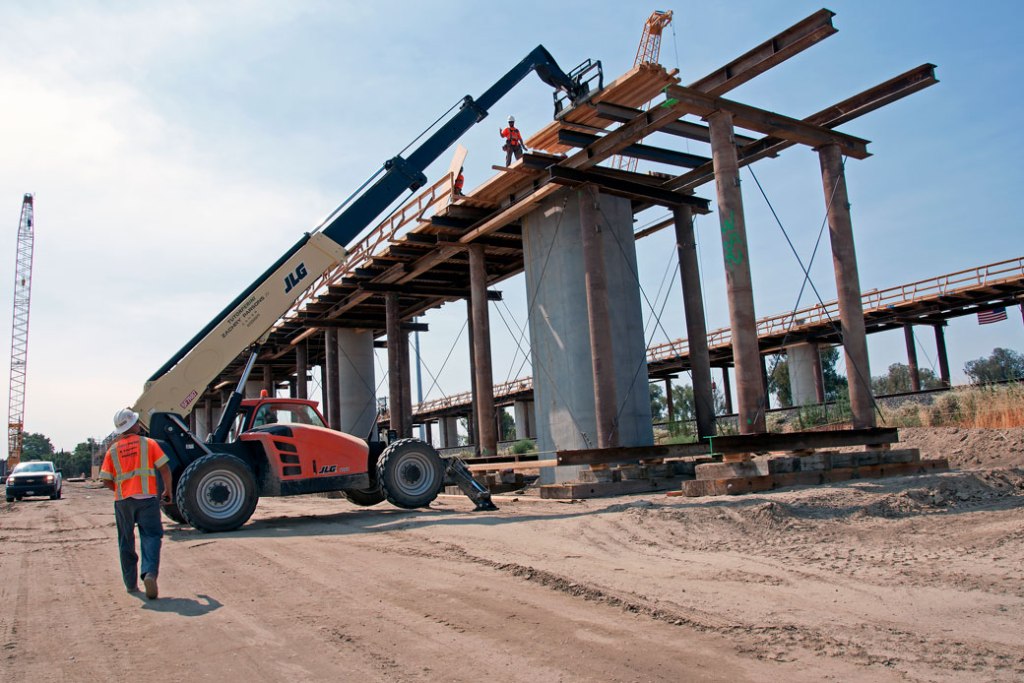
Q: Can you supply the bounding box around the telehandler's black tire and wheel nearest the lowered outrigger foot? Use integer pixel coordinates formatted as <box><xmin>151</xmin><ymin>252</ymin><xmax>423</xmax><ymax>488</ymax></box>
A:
<box><xmin>377</xmin><ymin>438</ymin><xmax>444</xmax><ymax>510</ymax></box>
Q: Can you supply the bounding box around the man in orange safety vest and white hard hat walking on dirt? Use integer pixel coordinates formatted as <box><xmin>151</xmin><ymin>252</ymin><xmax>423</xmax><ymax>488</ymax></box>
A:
<box><xmin>99</xmin><ymin>408</ymin><xmax>173</xmax><ymax>600</ymax></box>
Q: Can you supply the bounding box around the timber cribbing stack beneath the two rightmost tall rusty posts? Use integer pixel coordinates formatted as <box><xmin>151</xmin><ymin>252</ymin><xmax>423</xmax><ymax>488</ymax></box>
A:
<box><xmin>682</xmin><ymin>456</ymin><xmax>949</xmax><ymax>497</ymax></box>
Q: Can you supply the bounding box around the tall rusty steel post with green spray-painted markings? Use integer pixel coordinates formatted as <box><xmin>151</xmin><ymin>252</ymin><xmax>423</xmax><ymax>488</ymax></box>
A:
<box><xmin>707</xmin><ymin>111</ymin><xmax>767</xmax><ymax>434</ymax></box>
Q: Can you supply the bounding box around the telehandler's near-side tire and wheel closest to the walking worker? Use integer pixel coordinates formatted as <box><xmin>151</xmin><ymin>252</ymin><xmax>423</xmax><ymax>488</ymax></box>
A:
<box><xmin>175</xmin><ymin>453</ymin><xmax>259</xmax><ymax>531</ymax></box>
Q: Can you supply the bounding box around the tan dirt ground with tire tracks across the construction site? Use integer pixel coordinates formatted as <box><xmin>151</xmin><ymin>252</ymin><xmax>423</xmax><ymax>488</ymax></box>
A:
<box><xmin>0</xmin><ymin>429</ymin><xmax>1024</xmax><ymax>683</ymax></box>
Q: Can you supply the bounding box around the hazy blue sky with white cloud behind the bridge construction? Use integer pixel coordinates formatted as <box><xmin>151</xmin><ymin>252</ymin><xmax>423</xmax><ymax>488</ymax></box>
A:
<box><xmin>0</xmin><ymin>0</ymin><xmax>1024</xmax><ymax>452</ymax></box>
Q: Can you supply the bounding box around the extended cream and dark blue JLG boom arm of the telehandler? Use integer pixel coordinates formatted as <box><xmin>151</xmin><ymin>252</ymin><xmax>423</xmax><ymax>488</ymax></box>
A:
<box><xmin>133</xmin><ymin>45</ymin><xmax>591</xmax><ymax>425</ymax></box>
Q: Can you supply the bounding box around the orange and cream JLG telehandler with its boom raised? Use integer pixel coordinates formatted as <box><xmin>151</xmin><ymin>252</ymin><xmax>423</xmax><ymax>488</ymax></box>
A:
<box><xmin>132</xmin><ymin>46</ymin><xmax>603</xmax><ymax>531</ymax></box>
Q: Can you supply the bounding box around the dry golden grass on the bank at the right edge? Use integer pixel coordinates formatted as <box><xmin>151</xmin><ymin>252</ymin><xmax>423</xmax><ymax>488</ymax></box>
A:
<box><xmin>884</xmin><ymin>384</ymin><xmax>1024</xmax><ymax>429</ymax></box>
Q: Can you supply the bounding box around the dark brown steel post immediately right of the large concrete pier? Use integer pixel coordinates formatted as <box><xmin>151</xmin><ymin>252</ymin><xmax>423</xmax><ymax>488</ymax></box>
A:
<box><xmin>670</xmin><ymin>205</ymin><xmax>715</xmax><ymax>440</ymax></box>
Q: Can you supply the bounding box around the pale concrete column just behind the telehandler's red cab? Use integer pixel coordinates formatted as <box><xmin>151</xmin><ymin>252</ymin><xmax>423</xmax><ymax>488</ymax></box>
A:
<box><xmin>336</xmin><ymin>329</ymin><xmax>377</xmax><ymax>438</ymax></box>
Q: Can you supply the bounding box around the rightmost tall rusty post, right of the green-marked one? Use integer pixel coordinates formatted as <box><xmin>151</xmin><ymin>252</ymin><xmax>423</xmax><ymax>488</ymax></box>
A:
<box><xmin>818</xmin><ymin>144</ymin><xmax>876</xmax><ymax>428</ymax></box>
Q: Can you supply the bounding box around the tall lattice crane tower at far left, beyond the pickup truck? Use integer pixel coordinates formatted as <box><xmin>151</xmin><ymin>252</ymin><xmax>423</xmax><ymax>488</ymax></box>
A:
<box><xmin>7</xmin><ymin>194</ymin><xmax>35</xmax><ymax>471</ymax></box>
